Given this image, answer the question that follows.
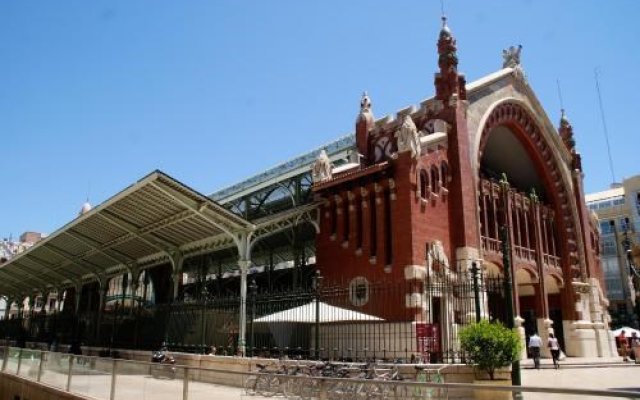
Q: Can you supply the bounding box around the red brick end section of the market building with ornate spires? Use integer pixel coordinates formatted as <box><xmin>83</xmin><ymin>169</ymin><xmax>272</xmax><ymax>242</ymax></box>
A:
<box><xmin>314</xmin><ymin>18</ymin><xmax>607</xmax><ymax>358</ymax></box>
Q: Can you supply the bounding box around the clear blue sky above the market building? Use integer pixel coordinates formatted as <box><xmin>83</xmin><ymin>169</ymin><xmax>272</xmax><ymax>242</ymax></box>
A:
<box><xmin>0</xmin><ymin>0</ymin><xmax>640</xmax><ymax>238</ymax></box>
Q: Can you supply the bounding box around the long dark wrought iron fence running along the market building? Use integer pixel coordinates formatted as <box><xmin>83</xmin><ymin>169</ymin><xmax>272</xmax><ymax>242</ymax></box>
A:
<box><xmin>0</xmin><ymin>273</ymin><xmax>504</xmax><ymax>363</ymax></box>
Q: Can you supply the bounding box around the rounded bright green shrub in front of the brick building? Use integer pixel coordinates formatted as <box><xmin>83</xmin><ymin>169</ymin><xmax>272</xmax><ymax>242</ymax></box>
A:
<box><xmin>459</xmin><ymin>320</ymin><xmax>521</xmax><ymax>380</ymax></box>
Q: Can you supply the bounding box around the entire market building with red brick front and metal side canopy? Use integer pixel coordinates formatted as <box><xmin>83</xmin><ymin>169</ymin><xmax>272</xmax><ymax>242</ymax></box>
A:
<box><xmin>0</xmin><ymin>20</ymin><xmax>612</xmax><ymax>362</ymax></box>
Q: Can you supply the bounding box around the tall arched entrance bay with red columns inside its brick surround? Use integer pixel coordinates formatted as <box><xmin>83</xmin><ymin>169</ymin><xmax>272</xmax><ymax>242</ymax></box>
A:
<box><xmin>477</xmin><ymin>101</ymin><xmax>580</xmax><ymax>346</ymax></box>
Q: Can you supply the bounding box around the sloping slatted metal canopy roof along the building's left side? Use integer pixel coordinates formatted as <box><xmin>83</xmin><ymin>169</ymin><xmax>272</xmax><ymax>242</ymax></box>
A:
<box><xmin>0</xmin><ymin>171</ymin><xmax>256</xmax><ymax>295</ymax></box>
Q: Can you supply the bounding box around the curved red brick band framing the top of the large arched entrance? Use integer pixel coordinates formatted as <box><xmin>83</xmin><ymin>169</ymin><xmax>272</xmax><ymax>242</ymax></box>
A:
<box><xmin>473</xmin><ymin>98</ymin><xmax>586</xmax><ymax>319</ymax></box>
